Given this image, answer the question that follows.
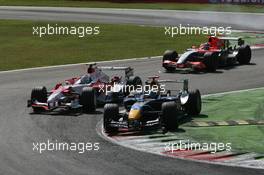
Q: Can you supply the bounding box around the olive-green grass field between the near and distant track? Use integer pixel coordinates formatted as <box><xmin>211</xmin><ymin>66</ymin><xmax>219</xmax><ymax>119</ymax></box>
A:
<box><xmin>0</xmin><ymin>20</ymin><xmax>206</xmax><ymax>71</ymax></box>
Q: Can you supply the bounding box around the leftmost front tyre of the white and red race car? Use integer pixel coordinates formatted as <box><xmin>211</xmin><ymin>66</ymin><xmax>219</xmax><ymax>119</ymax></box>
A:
<box><xmin>31</xmin><ymin>86</ymin><xmax>48</xmax><ymax>113</ymax></box>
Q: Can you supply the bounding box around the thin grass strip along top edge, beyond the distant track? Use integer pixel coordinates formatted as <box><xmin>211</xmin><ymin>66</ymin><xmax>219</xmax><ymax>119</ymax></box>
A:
<box><xmin>0</xmin><ymin>0</ymin><xmax>264</xmax><ymax>13</ymax></box>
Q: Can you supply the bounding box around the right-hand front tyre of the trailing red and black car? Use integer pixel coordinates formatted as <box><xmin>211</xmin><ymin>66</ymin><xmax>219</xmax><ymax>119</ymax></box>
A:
<box><xmin>203</xmin><ymin>52</ymin><xmax>219</xmax><ymax>72</ymax></box>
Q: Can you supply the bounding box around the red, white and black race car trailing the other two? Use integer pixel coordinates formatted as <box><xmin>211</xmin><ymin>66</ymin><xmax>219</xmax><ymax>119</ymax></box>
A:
<box><xmin>162</xmin><ymin>36</ymin><xmax>251</xmax><ymax>72</ymax></box>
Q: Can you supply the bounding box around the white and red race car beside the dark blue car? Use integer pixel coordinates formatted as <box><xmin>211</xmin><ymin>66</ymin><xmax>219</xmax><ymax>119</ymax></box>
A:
<box><xmin>28</xmin><ymin>64</ymin><xmax>142</xmax><ymax>112</ymax></box>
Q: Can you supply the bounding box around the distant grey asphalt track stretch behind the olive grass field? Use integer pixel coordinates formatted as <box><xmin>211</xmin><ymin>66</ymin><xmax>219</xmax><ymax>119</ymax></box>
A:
<box><xmin>0</xmin><ymin>6</ymin><xmax>264</xmax><ymax>30</ymax></box>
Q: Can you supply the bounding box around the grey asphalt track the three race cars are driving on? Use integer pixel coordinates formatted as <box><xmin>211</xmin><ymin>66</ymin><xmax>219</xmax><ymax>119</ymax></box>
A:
<box><xmin>0</xmin><ymin>6</ymin><xmax>264</xmax><ymax>175</ymax></box>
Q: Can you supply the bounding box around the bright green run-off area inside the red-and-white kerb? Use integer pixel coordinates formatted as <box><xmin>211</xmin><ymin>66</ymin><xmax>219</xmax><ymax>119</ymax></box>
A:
<box><xmin>178</xmin><ymin>89</ymin><xmax>264</xmax><ymax>154</ymax></box>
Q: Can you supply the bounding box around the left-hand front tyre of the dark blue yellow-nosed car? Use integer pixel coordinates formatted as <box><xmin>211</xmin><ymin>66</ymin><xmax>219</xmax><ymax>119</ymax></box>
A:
<box><xmin>104</xmin><ymin>103</ymin><xmax>119</xmax><ymax>133</ymax></box>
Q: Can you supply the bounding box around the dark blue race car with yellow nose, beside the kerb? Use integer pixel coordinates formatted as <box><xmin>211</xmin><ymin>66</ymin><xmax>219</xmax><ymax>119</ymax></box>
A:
<box><xmin>103</xmin><ymin>77</ymin><xmax>201</xmax><ymax>133</ymax></box>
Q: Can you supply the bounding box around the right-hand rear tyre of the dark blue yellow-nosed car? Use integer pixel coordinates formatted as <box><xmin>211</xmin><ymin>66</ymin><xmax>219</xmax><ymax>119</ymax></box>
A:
<box><xmin>185</xmin><ymin>89</ymin><xmax>202</xmax><ymax>115</ymax></box>
